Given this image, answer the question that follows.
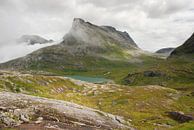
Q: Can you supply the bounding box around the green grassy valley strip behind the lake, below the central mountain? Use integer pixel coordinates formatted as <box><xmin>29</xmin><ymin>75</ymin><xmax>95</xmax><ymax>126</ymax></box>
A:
<box><xmin>20</xmin><ymin>55</ymin><xmax>164</xmax><ymax>84</ymax></box>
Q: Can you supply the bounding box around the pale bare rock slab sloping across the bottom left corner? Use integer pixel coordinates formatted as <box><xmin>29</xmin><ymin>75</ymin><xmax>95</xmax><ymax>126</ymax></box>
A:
<box><xmin>0</xmin><ymin>92</ymin><xmax>132</xmax><ymax>129</ymax></box>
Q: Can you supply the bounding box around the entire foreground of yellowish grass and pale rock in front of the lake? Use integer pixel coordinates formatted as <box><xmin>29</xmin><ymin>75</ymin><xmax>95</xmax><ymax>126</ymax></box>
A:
<box><xmin>0</xmin><ymin>71</ymin><xmax>194</xmax><ymax>130</ymax></box>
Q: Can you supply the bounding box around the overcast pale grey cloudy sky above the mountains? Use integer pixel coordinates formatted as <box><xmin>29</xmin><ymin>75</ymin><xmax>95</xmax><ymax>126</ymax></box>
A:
<box><xmin>0</xmin><ymin>0</ymin><xmax>194</xmax><ymax>51</ymax></box>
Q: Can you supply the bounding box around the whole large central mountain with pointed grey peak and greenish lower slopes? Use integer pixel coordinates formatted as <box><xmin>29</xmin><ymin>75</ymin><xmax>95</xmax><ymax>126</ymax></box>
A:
<box><xmin>0</xmin><ymin>18</ymin><xmax>143</xmax><ymax>70</ymax></box>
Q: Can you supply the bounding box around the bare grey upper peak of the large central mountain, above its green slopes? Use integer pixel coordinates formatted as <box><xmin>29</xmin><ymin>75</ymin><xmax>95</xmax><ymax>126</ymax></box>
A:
<box><xmin>64</xmin><ymin>18</ymin><xmax>138</xmax><ymax>49</ymax></box>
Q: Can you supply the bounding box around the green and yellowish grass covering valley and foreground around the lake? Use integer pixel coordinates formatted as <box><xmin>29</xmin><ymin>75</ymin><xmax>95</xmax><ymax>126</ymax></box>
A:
<box><xmin>0</xmin><ymin>52</ymin><xmax>194</xmax><ymax>130</ymax></box>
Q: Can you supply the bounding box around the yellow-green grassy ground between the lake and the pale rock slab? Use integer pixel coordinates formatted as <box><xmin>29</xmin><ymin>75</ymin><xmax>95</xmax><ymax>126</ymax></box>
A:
<box><xmin>0</xmin><ymin>72</ymin><xmax>194</xmax><ymax>129</ymax></box>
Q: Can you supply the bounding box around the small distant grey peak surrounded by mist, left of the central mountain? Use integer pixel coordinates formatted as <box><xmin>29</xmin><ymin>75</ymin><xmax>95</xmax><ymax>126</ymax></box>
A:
<box><xmin>17</xmin><ymin>35</ymin><xmax>52</xmax><ymax>45</ymax></box>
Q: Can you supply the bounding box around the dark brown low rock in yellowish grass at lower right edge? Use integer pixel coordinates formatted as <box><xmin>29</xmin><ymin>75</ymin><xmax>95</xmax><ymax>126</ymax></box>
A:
<box><xmin>167</xmin><ymin>112</ymin><xmax>194</xmax><ymax>123</ymax></box>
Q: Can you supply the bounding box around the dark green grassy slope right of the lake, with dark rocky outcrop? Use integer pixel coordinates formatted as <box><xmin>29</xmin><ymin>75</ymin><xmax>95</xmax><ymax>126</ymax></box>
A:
<box><xmin>124</xmin><ymin>58</ymin><xmax>194</xmax><ymax>91</ymax></box>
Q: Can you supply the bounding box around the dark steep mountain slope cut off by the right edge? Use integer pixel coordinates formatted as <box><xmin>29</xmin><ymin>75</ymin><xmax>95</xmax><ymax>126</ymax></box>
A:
<box><xmin>170</xmin><ymin>33</ymin><xmax>194</xmax><ymax>57</ymax></box>
